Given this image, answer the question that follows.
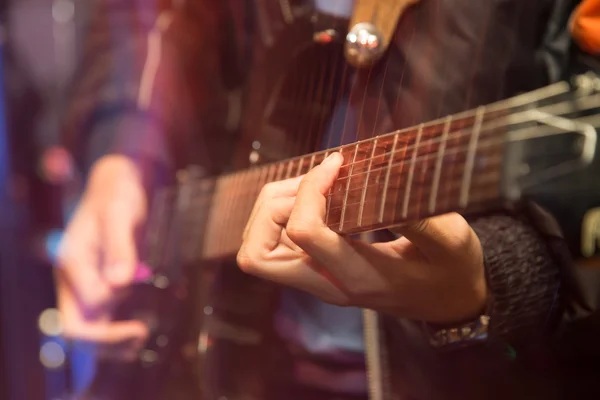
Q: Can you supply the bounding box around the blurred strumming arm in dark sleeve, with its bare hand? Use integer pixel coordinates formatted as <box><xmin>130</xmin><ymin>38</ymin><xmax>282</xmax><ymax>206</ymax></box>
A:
<box><xmin>57</xmin><ymin>1</ymin><xmax>221</xmax><ymax>348</ymax></box>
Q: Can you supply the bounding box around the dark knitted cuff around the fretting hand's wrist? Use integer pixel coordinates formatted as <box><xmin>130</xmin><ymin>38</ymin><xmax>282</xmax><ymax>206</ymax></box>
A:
<box><xmin>471</xmin><ymin>209</ymin><xmax>568</xmax><ymax>341</ymax></box>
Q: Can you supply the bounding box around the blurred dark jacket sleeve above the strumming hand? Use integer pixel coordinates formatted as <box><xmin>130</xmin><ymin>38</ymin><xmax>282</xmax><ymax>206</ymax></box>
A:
<box><xmin>63</xmin><ymin>0</ymin><xmax>233</xmax><ymax>184</ymax></box>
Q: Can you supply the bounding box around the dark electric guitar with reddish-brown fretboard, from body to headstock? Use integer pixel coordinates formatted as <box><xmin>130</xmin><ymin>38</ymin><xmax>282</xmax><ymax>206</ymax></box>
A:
<box><xmin>75</xmin><ymin>3</ymin><xmax>600</xmax><ymax>400</ymax></box>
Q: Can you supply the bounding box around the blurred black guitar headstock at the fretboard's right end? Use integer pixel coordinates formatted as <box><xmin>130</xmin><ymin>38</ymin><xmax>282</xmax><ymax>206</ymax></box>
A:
<box><xmin>503</xmin><ymin>73</ymin><xmax>600</xmax><ymax>257</ymax></box>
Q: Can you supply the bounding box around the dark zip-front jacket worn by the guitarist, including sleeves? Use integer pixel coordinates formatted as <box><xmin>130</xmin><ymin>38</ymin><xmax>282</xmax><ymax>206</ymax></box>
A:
<box><xmin>65</xmin><ymin>0</ymin><xmax>600</xmax><ymax>400</ymax></box>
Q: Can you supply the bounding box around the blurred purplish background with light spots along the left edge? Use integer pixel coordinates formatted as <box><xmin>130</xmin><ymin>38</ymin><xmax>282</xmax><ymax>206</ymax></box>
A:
<box><xmin>0</xmin><ymin>0</ymin><xmax>88</xmax><ymax>400</ymax></box>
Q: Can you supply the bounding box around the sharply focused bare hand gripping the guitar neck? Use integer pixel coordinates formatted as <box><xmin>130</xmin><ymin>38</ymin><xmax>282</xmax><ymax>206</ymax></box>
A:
<box><xmin>237</xmin><ymin>153</ymin><xmax>487</xmax><ymax>323</ymax></box>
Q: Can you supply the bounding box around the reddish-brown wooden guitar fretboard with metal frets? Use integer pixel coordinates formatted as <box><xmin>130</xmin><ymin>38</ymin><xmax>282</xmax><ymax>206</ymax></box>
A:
<box><xmin>203</xmin><ymin>107</ymin><xmax>506</xmax><ymax>258</ymax></box>
